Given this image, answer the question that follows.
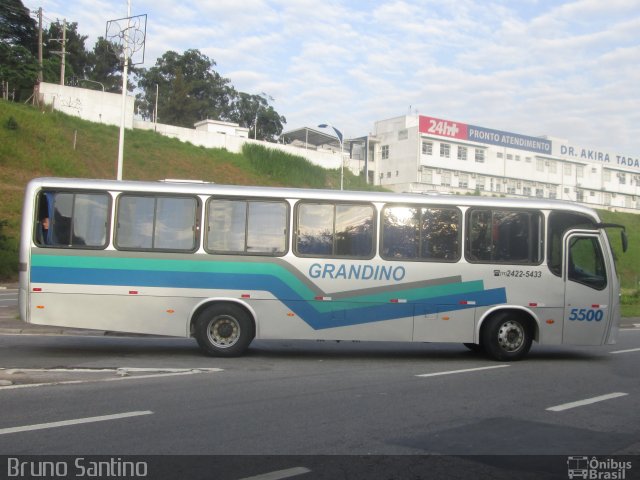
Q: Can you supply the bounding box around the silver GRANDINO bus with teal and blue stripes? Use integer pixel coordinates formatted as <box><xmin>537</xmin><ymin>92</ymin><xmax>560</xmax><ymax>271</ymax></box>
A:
<box><xmin>19</xmin><ymin>178</ymin><xmax>626</xmax><ymax>361</ymax></box>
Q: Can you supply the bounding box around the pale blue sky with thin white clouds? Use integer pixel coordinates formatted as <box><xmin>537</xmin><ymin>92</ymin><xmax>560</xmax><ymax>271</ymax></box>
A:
<box><xmin>23</xmin><ymin>0</ymin><xmax>640</xmax><ymax>158</ymax></box>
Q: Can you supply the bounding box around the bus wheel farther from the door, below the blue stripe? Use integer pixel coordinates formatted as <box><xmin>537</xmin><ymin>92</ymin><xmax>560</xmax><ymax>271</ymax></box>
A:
<box><xmin>194</xmin><ymin>303</ymin><xmax>255</xmax><ymax>357</ymax></box>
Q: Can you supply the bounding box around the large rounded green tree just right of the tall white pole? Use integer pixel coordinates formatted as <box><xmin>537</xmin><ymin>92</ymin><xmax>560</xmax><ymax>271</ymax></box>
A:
<box><xmin>138</xmin><ymin>50</ymin><xmax>235</xmax><ymax>128</ymax></box>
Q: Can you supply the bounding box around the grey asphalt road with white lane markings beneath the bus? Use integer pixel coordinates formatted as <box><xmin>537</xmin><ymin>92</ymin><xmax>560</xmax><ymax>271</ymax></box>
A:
<box><xmin>0</xmin><ymin>286</ymin><xmax>640</xmax><ymax>479</ymax></box>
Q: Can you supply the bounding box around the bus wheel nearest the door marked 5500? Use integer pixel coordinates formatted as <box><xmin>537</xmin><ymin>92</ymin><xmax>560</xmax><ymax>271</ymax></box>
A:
<box><xmin>480</xmin><ymin>312</ymin><xmax>533</xmax><ymax>361</ymax></box>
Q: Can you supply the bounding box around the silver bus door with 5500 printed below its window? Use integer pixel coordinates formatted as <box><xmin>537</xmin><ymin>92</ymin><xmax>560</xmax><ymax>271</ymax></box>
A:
<box><xmin>562</xmin><ymin>231</ymin><xmax>612</xmax><ymax>345</ymax></box>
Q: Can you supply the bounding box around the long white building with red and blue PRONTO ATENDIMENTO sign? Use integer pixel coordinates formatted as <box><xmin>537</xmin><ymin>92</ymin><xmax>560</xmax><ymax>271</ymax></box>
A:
<box><xmin>368</xmin><ymin>115</ymin><xmax>640</xmax><ymax>213</ymax></box>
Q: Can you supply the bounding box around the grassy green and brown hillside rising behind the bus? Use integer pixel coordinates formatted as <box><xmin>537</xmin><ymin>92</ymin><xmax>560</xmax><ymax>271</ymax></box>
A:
<box><xmin>0</xmin><ymin>100</ymin><xmax>640</xmax><ymax>315</ymax></box>
